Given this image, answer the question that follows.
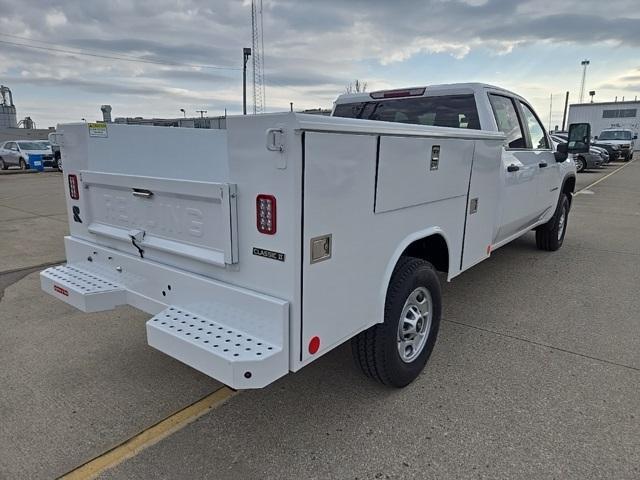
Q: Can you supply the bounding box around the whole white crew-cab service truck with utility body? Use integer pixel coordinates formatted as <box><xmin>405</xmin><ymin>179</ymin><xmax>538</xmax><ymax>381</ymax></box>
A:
<box><xmin>41</xmin><ymin>84</ymin><xmax>590</xmax><ymax>389</ymax></box>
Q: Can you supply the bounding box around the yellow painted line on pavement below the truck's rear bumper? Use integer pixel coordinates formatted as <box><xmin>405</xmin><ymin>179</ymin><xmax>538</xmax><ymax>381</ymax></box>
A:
<box><xmin>60</xmin><ymin>387</ymin><xmax>236</xmax><ymax>480</ymax></box>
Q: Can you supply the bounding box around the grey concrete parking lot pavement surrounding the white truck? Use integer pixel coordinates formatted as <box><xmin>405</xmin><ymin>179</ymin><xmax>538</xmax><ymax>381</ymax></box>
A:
<box><xmin>0</xmin><ymin>162</ymin><xmax>640</xmax><ymax>479</ymax></box>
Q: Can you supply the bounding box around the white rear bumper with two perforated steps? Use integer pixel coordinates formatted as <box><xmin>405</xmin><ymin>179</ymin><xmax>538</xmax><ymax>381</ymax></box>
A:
<box><xmin>40</xmin><ymin>237</ymin><xmax>289</xmax><ymax>389</ymax></box>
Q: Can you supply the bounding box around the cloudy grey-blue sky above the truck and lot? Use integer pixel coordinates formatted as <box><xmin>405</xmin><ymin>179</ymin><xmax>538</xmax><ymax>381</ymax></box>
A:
<box><xmin>0</xmin><ymin>0</ymin><xmax>640</xmax><ymax>127</ymax></box>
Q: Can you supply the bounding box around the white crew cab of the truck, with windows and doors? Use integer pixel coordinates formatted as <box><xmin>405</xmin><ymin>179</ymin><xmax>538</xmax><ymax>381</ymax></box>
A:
<box><xmin>332</xmin><ymin>83</ymin><xmax>575</xmax><ymax>249</ymax></box>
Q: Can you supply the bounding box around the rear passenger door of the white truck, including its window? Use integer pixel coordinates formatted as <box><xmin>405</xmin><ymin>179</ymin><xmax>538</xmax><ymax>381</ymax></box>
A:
<box><xmin>489</xmin><ymin>93</ymin><xmax>544</xmax><ymax>243</ymax></box>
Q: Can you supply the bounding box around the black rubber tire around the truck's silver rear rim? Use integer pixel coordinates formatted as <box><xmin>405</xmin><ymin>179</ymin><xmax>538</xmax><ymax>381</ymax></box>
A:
<box><xmin>351</xmin><ymin>257</ymin><xmax>442</xmax><ymax>388</ymax></box>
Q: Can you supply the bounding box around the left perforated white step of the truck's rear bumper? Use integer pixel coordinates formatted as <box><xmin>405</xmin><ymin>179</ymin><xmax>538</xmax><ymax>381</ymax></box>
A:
<box><xmin>40</xmin><ymin>265</ymin><xmax>127</xmax><ymax>312</ymax></box>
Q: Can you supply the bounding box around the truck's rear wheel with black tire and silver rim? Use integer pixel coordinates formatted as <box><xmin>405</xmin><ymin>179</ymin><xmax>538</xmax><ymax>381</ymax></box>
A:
<box><xmin>351</xmin><ymin>257</ymin><xmax>442</xmax><ymax>388</ymax></box>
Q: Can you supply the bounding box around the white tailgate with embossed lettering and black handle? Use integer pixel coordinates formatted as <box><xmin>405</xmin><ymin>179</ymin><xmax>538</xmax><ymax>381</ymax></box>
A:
<box><xmin>80</xmin><ymin>170</ymin><xmax>238</xmax><ymax>266</ymax></box>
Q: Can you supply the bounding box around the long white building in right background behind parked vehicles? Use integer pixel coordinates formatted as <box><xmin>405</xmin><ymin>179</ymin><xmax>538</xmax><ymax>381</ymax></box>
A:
<box><xmin>567</xmin><ymin>100</ymin><xmax>640</xmax><ymax>150</ymax></box>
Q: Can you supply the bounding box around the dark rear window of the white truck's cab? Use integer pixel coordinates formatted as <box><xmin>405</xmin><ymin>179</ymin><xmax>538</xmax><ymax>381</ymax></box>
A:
<box><xmin>333</xmin><ymin>95</ymin><xmax>480</xmax><ymax>130</ymax></box>
